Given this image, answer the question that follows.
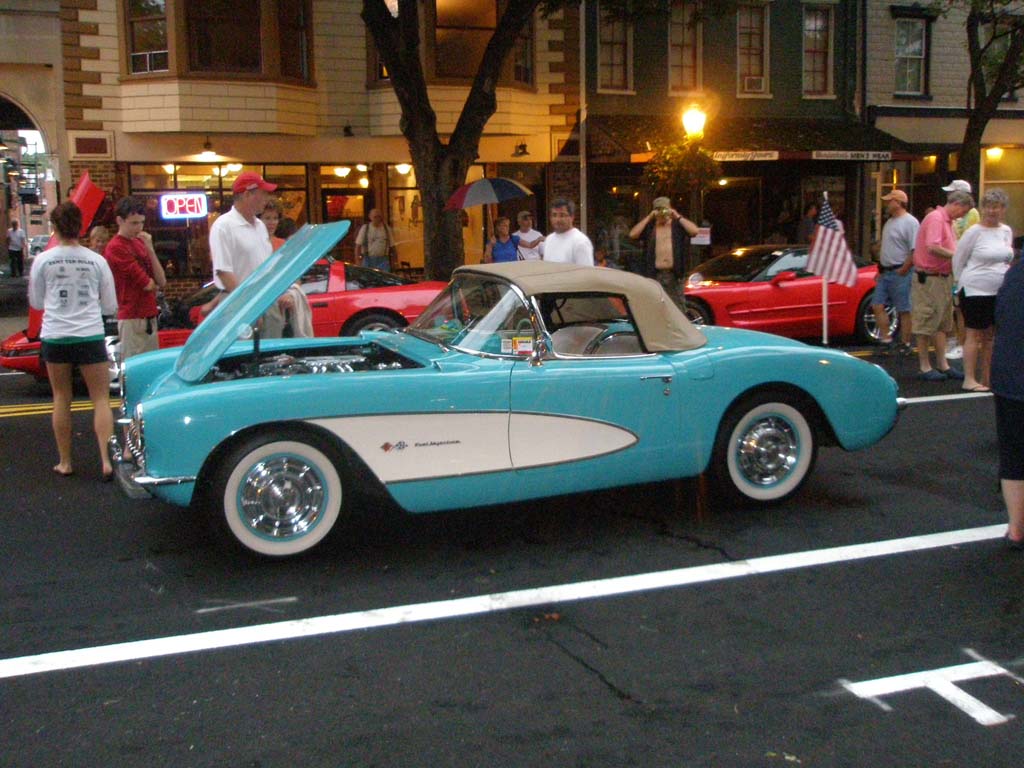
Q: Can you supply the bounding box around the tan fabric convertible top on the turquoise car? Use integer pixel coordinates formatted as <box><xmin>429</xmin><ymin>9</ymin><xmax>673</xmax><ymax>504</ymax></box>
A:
<box><xmin>455</xmin><ymin>261</ymin><xmax>707</xmax><ymax>352</ymax></box>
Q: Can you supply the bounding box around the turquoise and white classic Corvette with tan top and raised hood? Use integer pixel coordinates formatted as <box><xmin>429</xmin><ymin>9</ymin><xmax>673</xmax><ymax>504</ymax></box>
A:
<box><xmin>114</xmin><ymin>222</ymin><xmax>898</xmax><ymax>556</ymax></box>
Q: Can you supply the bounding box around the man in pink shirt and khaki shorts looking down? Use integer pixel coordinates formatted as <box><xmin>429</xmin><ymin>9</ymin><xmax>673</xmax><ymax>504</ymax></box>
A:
<box><xmin>910</xmin><ymin>191</ymin><xmax>974</xmax><ymax>381</ymax></box>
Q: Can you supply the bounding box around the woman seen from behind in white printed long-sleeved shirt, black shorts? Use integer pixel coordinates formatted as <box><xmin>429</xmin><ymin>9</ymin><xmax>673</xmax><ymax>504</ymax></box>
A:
<box><xmin>29</xmin><ymin>202</ymin><xmax>118</xmax><ymax>482</ymax></box>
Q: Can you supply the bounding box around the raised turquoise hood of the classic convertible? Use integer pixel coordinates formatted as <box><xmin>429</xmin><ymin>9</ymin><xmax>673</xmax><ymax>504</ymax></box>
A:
<box><xmin>174</xmin><ymin>221</ymin><xmax>351</xmax><ymax>382</ymax></box>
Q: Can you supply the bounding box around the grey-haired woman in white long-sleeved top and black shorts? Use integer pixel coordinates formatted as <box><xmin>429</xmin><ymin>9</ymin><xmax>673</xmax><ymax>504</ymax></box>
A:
<box><xmin>953</xmin><ymin>189</ymin><xmax>1014</xmax><ymax>392</ymax></box>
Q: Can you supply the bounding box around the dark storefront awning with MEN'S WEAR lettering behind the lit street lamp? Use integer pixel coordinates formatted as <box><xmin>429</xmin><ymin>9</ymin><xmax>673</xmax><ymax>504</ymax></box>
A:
<box><xmin>573</xmin><ymin>115</ymin><xmax>916</xmax><ymax>163</ymax></box>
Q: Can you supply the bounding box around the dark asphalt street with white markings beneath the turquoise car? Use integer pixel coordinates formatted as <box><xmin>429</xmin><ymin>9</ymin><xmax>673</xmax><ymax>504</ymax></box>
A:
<box><xmin>0</xmin><ymin>280</ymin><xmax>1024</xmax><ymax>768</ymax></box>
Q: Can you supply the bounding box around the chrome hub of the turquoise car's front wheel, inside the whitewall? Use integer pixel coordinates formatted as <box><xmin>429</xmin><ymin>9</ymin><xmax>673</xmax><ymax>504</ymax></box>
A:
<box><xmin>239</xmin><ymin>457</ymin><xmax>327</xmax><ymax>539</ymax></box>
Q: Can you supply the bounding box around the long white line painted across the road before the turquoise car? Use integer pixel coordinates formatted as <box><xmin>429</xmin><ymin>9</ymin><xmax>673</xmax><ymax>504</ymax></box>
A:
<box><xmin>0</xmin><ymin>523</ymin><xmax>1007</xmax><ymax>679</ymax></box>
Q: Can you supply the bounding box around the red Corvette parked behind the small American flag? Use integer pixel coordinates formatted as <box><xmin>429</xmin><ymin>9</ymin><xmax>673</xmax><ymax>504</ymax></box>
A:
<box><xmin>685</xmin><ymin>246</ymin><xmax>896</xmax><ymax>343</ymax></box>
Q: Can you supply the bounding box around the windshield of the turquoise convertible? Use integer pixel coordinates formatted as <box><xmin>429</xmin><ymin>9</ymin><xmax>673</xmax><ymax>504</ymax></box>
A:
<box><xmin>409</xmin><ymin>273</ymin><xmax>534</xmax><ymax>356</ymax></box>
